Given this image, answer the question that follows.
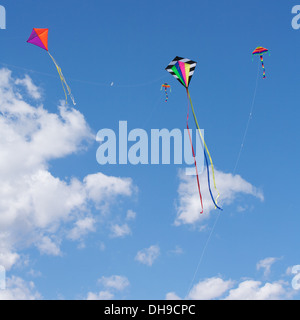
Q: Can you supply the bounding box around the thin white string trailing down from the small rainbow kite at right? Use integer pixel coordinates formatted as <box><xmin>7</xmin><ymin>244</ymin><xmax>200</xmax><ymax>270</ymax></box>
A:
<box><xmin>186</xmin><ymin>64</ymin><xmax>260</xmax><ymax>297</ymax></box>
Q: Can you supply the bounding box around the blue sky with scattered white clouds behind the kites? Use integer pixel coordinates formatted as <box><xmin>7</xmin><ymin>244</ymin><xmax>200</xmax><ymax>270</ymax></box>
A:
<box><xmin>0</xmin><ymin>0</ymin><xmax>300</xmax><ymax>299</ymax></box>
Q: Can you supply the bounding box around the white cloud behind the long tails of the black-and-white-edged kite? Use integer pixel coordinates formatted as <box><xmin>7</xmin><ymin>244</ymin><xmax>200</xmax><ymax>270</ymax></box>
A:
<box><xmin>175</xmin><ymin>170</ymin><xmax>264</xmax><ymax>226</ymax></box>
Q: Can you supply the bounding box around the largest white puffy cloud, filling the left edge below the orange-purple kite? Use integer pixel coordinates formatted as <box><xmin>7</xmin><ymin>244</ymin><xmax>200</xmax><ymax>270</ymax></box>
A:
<box><xmin>0</xmin><ymin>69</ymin><xmax>135</xmax><ymax>270</ymax></box>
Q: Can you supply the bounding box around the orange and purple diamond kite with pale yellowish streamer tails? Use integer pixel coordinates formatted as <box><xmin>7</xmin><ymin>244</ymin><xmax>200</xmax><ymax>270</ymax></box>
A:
<box><xmin>27</xmin><ymin>28</ymin><xmax>76</xmax><ymax>106</ymax></box>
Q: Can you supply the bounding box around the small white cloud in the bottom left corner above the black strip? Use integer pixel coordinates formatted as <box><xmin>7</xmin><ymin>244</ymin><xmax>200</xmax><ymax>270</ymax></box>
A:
<box><xmin>0</xmin><ymin>277</ymin><xmax>42</xmax><ymax>300</ymax></box>
